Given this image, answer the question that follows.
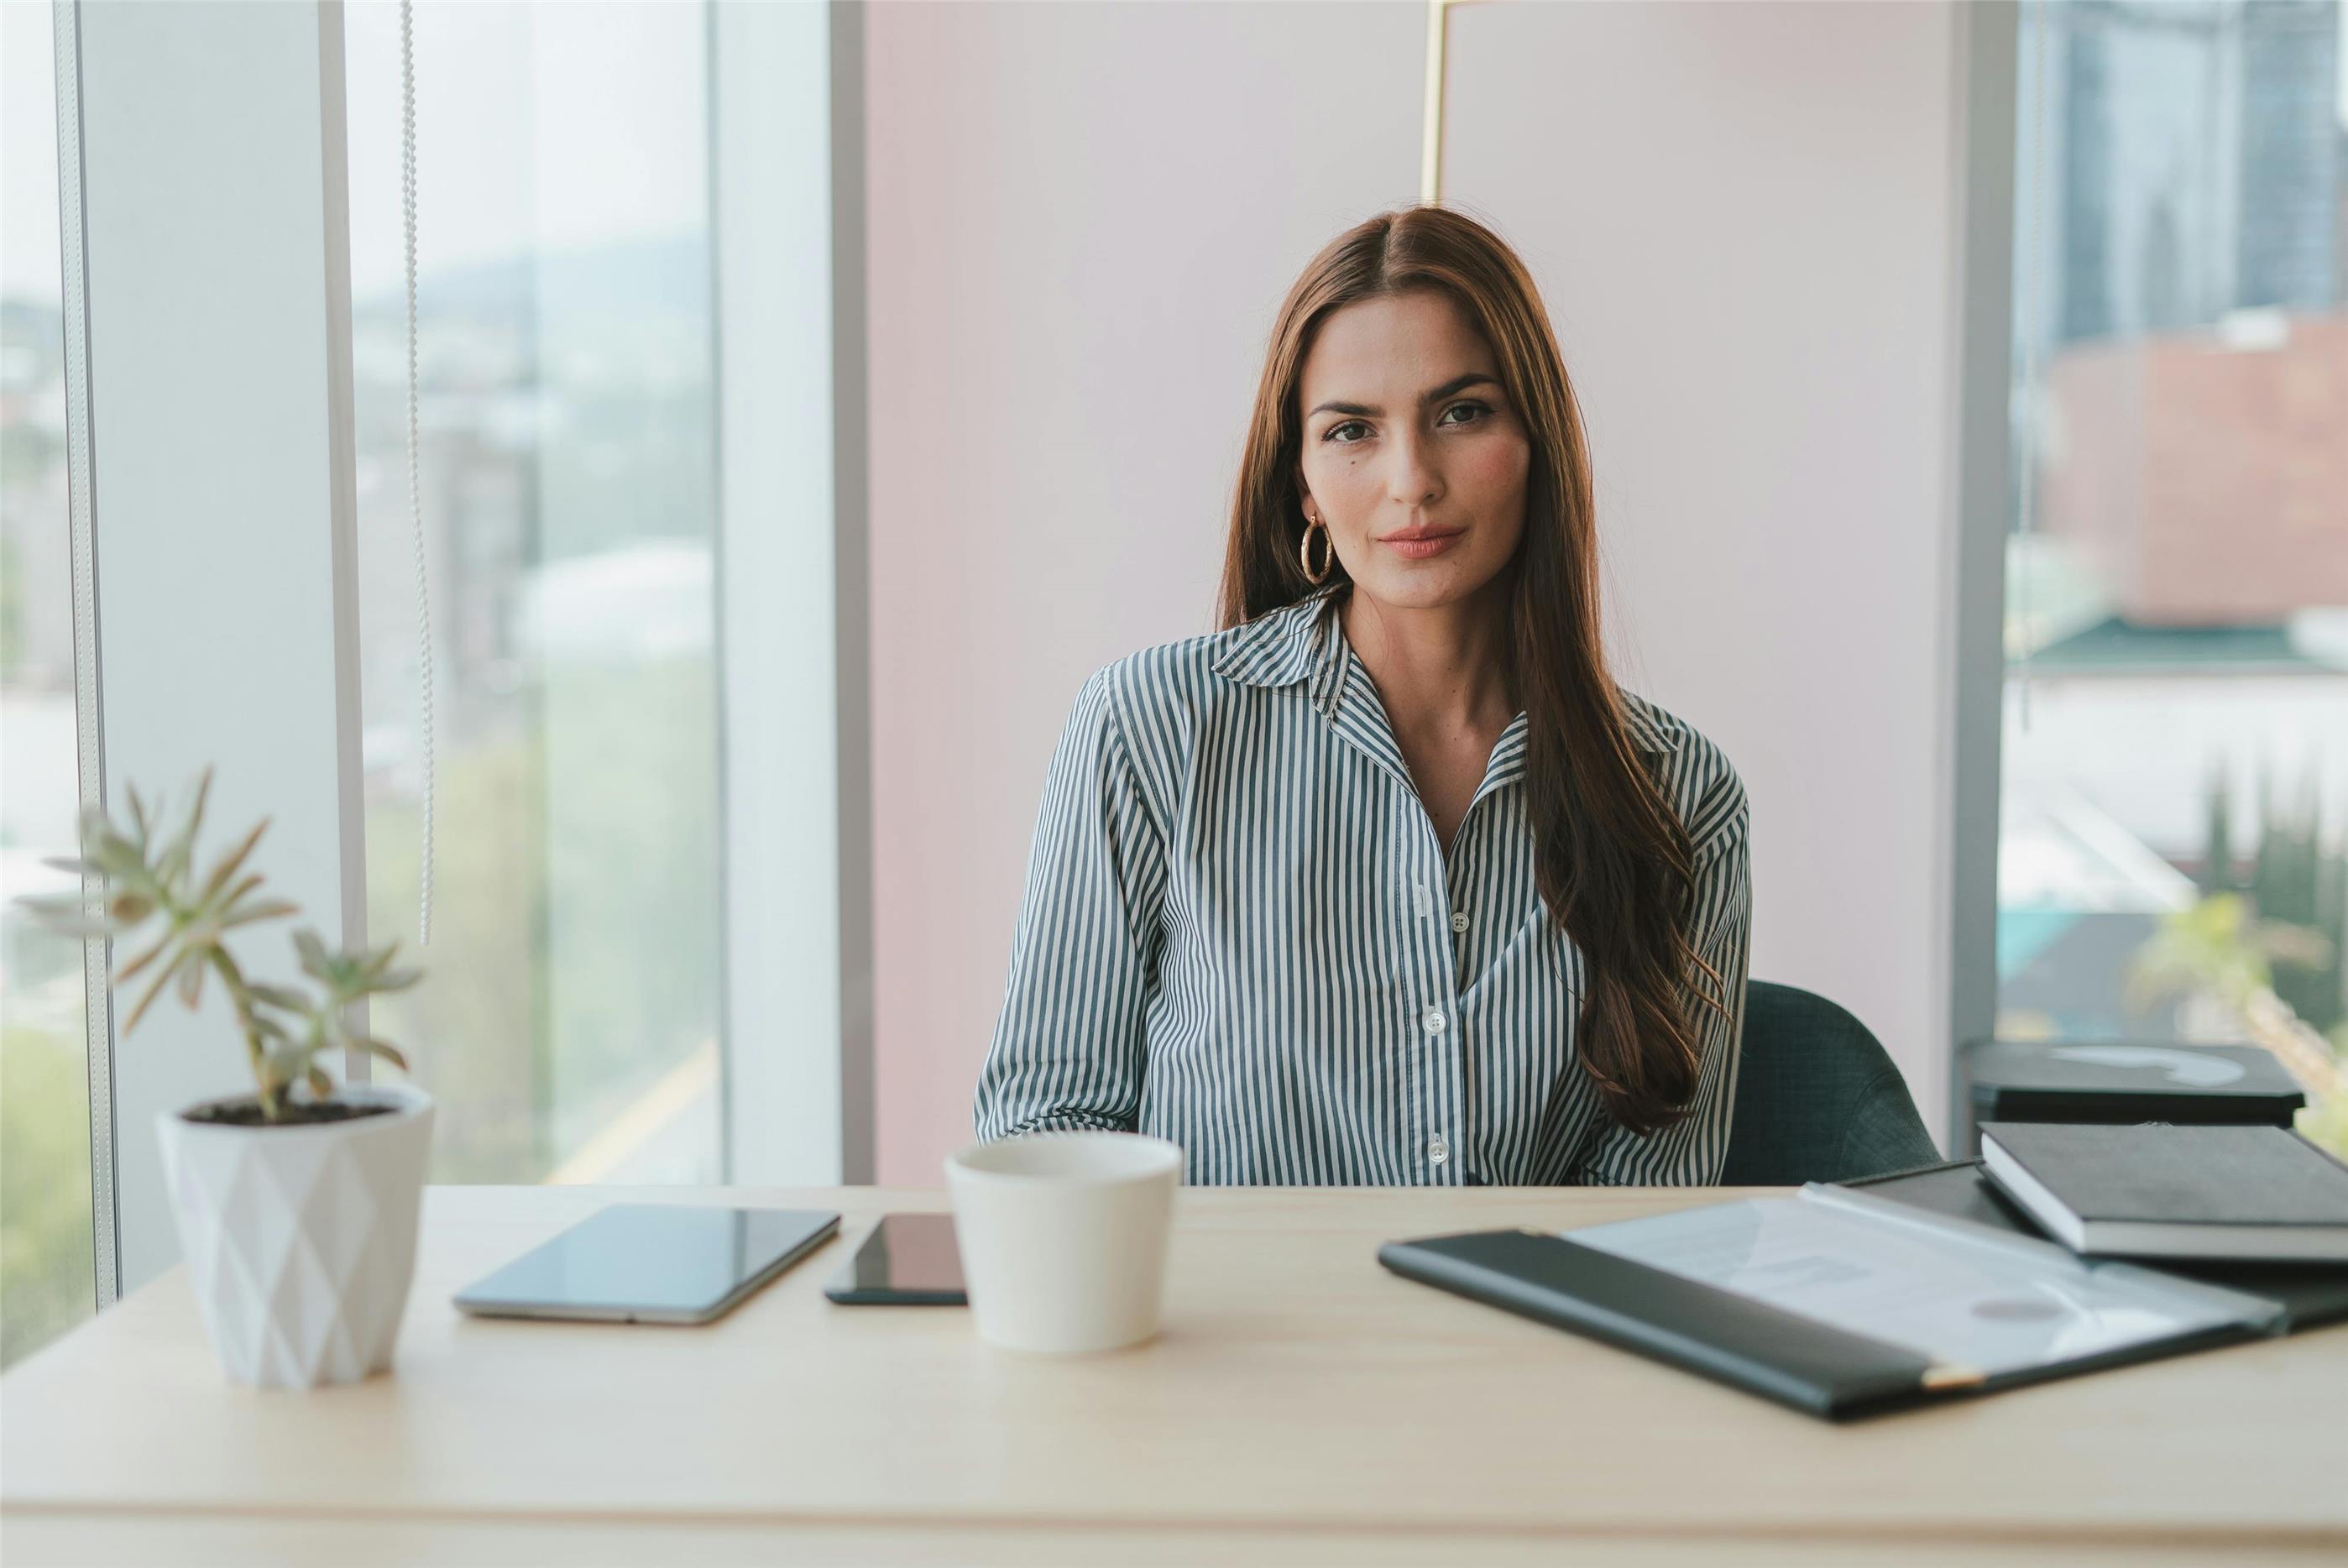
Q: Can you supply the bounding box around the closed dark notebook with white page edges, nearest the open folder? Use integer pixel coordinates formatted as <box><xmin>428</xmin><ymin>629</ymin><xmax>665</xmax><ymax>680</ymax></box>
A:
<box><xmin>1982</xmin><ymin>1122</ymin><xmax>2348</xmax><ymax>1262</ymax></box>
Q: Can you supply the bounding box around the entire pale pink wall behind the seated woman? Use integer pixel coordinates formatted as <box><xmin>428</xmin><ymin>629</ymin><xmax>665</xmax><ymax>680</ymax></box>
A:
<box><xmin>866</xmin><ymin>3</ymin><xmax>1953</xmax><ymax>1185</ymax></box>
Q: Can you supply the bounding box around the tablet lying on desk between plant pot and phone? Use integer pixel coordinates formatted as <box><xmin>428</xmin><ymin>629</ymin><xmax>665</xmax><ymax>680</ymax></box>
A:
<box><xmin>456</xmin><ymin>1205</ymin><xmax>840</xmax><ymax>1324</ymax></box>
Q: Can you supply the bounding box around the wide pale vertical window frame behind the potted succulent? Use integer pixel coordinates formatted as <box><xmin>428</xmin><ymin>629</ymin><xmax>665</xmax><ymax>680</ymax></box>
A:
<box><xmin>56</xmin><ymin>0</ymin><xmax>366</xmax><ymax>1305</ymax></box>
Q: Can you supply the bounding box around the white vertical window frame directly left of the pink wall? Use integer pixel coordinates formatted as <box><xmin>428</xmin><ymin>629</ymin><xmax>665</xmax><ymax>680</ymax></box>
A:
<box><xmin>709</xmin><ymin>0</ymin><xmax>873</xmax><ymax>1185</ymax></box>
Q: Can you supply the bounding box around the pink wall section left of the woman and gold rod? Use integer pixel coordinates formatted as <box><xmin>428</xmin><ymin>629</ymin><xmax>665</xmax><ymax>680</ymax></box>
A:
<box><xmin>864</xmin><ymin>5</ymin><xmax>1423</xmax><ymax>1185</ymax></box>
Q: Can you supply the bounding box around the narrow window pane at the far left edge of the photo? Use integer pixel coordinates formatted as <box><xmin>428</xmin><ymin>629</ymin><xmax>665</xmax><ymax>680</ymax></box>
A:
<box><xmin>0</xmin><ymin>5</ymin><xmax>97</xmax><ymax>1367</ymax></box>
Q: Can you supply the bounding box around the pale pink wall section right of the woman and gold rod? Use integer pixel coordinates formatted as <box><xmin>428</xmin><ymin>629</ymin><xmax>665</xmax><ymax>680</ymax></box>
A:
<box><xmin>1451</xmin><ymin>3</ymin><xmax>1963</xmax><ymax>1129</ymax></box>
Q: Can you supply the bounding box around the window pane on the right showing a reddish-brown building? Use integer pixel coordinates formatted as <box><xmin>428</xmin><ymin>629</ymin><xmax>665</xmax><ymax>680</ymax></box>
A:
<box><xmin>1998</xmin><ymin>0</ymin><xmax>2348</xmax><ymax>1146</ymax></box>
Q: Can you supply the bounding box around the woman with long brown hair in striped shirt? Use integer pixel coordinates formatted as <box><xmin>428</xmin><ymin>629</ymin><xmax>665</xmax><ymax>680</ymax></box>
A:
<box><xmin>977</xmin><ymin>206</ymin><xmax>1752</xmax><ymax>1185</ymax></box>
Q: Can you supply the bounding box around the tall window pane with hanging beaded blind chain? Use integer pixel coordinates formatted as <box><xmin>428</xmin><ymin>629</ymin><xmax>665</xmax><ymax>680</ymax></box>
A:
<box><xmin>345</xmin><ymin>3</ymin><xmax>721</xmax><ymax>1181</ymax></box>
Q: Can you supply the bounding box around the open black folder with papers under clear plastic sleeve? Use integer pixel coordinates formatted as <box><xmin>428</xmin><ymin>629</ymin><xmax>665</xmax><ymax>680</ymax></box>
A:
<box><xmin>1378</xmin><ymin>1183</ymin><xmax>2284</xmax><ymax>1420</ymax></box>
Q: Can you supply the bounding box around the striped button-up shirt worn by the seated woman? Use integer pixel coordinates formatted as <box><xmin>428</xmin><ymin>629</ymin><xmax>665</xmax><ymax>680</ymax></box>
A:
<box><xmin>977</xmin><ymin>587</ymin><xmax>1752</xmax><ymax>1185</ymax></box>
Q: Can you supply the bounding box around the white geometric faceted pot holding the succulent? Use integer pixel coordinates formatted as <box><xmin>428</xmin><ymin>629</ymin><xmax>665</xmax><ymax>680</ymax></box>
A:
<box><xmin>155</xmin><ymin>1085</ymin><xmax>432</xmax><ymax>1388</ymax></box>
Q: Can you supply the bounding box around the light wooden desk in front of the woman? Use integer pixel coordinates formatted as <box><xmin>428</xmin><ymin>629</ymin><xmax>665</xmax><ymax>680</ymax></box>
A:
<box><xmin>0</xmin><ymin>1188</ymin><xmax>2348</xmax><ymax>1568</ymax></box>
